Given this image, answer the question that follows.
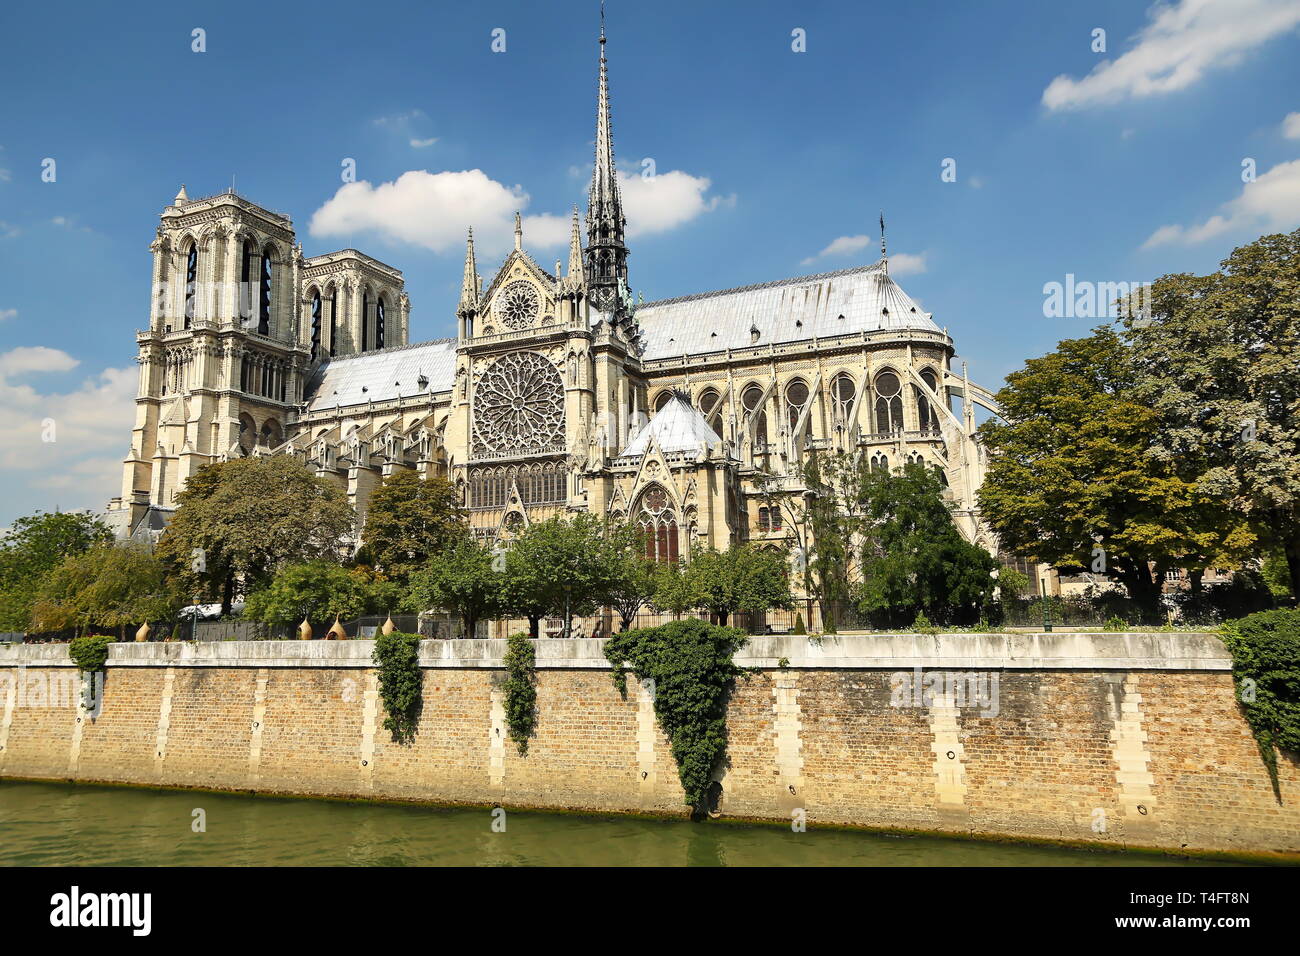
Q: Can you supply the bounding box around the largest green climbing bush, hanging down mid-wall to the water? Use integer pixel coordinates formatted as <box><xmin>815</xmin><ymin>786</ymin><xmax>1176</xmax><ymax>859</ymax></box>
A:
<box><xmin>605</xmin><ymin>619</ymin><xmax>746</xmax><ymax>814</ymax></box>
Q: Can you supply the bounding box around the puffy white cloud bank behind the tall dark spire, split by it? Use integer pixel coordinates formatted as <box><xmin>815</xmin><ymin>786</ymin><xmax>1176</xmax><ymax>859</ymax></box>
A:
<box><xmin>308</xmin><ymin>169</ymin><xmax>735</xmax><ymax>255</ymax></box>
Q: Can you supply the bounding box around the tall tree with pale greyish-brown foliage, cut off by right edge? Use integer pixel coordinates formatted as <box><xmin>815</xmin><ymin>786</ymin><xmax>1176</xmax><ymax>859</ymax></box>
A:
<box><xmin>1125</xmin><ymin>229</ymin><xmax>1300</xmax><ymax>594</ymax></box>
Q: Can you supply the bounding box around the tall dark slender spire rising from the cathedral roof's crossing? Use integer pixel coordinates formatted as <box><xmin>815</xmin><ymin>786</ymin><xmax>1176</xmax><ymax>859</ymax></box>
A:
<box><xmin>586</xmin><ymin>3</ymin><xmax>628</xmax><ymax>312</ymax></box>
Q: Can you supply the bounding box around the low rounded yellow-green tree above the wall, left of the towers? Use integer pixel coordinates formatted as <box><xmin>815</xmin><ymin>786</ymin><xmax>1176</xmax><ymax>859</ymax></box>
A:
<box><xmin>33</xmin><ymin>544</ymin><xmax>183</xmax><ymax>637</ymax></box>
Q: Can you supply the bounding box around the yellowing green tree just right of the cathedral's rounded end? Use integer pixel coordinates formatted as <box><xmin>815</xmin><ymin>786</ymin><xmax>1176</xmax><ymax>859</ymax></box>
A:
<box><xmin>979</xmin><ymin>326</ymin><xmax>1253</xmax><ymax>619</ymax></box>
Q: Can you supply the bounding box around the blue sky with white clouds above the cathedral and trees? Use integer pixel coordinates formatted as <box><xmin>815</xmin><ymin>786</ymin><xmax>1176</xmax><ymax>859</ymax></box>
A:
<box><xmin>0</xmin><ymin>0</ymin><xmax>1300</xmax><ymax>524</ymax></box>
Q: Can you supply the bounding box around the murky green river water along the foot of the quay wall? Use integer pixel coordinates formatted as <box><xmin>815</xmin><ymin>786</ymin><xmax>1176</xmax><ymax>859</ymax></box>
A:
<box><xmin>0</xmin><ymin>780</ymin><xmax>1248</xmax><ymax>866</ymax></box>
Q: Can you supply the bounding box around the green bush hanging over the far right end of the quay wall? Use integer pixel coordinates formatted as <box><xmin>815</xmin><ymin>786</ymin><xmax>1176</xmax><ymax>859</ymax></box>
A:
<box><xmin>1223</xmin><ymin>610</ymin><xmax>1300</xmax><ymax>801</ymax></box>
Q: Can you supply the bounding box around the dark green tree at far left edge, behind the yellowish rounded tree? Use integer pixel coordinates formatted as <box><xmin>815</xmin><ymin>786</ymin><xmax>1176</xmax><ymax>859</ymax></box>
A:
<box><xmin>0</xmin><ymin>511</ymin><xmax>113</xmax><ymax>631</ymax></box>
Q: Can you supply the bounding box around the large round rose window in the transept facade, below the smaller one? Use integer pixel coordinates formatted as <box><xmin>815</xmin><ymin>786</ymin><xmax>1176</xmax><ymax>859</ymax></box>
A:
<box><xmin>475</xmin><ymin>352</ymin><xmax>564</xmax><ymax>455</ymax></box>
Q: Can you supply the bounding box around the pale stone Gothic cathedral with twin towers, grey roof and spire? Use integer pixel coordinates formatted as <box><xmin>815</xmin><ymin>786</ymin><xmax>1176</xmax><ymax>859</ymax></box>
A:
<box><xmin>109</xmin><ymin>20</ymin><xmax>996</xmax><ymax>574</ymax></box>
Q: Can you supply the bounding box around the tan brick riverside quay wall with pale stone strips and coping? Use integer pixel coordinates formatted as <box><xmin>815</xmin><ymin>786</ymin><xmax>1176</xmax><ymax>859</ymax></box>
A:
<box><xmin>0</xmin><ymin>632</ymin><xmax>1300</xmax><ymax>853</ymax></box>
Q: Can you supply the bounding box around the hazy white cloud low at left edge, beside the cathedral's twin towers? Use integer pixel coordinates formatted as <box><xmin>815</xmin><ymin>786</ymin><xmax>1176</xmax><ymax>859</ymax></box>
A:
<box><xmin>0</xmin><ymin>346</ymin><xmax>137</xmax><ymax>511</ymax></box>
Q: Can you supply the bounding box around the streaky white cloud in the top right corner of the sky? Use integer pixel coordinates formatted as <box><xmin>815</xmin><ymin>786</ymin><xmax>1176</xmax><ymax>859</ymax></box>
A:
<box><xmin>1043</xmin><ymin>0</ymin><xmax>1300</xmax><ymax>109</ymax></box>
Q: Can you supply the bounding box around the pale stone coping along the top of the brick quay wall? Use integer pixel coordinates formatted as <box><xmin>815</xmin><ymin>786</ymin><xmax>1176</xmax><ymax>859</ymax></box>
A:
<box><xmin>0</xmin><ymin>631</ymin><xmax>1232</xmax><ymax>671</ymax></box>
